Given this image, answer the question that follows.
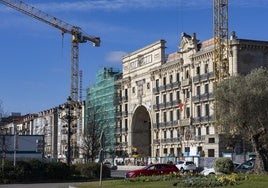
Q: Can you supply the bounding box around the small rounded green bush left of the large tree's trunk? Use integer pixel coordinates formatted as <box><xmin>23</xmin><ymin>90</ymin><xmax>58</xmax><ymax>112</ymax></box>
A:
<box><xmin>213</xmin><ymin>157</ymin><xmax>234</xmax><ymax>174</ymax></box>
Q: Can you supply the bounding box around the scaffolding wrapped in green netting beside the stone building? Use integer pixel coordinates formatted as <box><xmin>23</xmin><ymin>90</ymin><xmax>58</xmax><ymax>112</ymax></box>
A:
<box><xmin>85</xmin><ymin>68</ymin><xmax>122</xmax><ymax>158</ymax></box>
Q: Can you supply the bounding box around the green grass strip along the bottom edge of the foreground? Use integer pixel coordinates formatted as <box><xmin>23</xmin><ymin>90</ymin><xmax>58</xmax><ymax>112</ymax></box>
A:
<box><xmin>75</xmin><ymin>175</ymin><xmax>268</xmax><ymax>188</ymax></box>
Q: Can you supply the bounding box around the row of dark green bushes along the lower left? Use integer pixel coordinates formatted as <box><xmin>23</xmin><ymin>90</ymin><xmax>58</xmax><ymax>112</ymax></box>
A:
<box><xmin>0</xmin><ymin>159</ymin><xmax>111</xmax><ymax>183</ymax></box>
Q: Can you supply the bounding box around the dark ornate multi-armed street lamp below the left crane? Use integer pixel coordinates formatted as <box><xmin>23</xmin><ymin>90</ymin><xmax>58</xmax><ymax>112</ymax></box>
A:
<box><xmin>59</xmin><ymin>97</ymin><xmax>80</xmax><ymax>165</ymax></box>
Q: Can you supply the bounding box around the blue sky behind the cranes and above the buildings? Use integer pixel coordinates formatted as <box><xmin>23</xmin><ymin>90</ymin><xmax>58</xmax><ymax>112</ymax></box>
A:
<box><xmin>0</xmin><ymin>0</ymin><xmax>268</xmax><ymax>114</ymax></box>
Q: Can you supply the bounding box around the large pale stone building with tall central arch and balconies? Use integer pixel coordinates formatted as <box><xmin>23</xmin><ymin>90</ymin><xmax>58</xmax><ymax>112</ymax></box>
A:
<box><xmin>116</xmin><ymin>33</ymin><xmax>268</xmax><ymax>161</ymax></box>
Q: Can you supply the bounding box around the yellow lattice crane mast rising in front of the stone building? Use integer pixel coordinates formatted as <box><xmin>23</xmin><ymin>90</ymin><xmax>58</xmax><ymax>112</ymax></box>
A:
<box><xmin>213</xmin><ymin>0</ymin><xmax>229</xmax><ymax>84</ymax></box>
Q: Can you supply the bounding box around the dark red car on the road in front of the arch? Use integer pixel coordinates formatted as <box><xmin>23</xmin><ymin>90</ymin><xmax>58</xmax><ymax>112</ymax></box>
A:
<box><xmin>126</xmin><ymin>164</ymin><xmax>179</xmax><ymax>178</ymax></box>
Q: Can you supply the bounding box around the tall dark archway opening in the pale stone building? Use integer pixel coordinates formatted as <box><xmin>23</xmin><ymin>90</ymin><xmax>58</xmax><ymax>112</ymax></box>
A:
<box><xmin>132</xmin><ymin>106</ymin><xmax>151</xmax><ymax>157</ymax></box>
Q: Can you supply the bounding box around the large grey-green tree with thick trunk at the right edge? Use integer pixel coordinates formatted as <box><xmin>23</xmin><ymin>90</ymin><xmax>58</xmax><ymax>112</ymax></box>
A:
<box><xmin>214</xmin><ymin>68</ymin><xmax>268</xmax><ymax>174</ymax></box>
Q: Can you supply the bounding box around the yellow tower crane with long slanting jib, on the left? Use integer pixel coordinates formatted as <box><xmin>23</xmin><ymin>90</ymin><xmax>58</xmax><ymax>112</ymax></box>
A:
<box><xmin>0</xmin><ymin>0</ymin><xmax>100</xmax><ymax>101</ymax></box>
